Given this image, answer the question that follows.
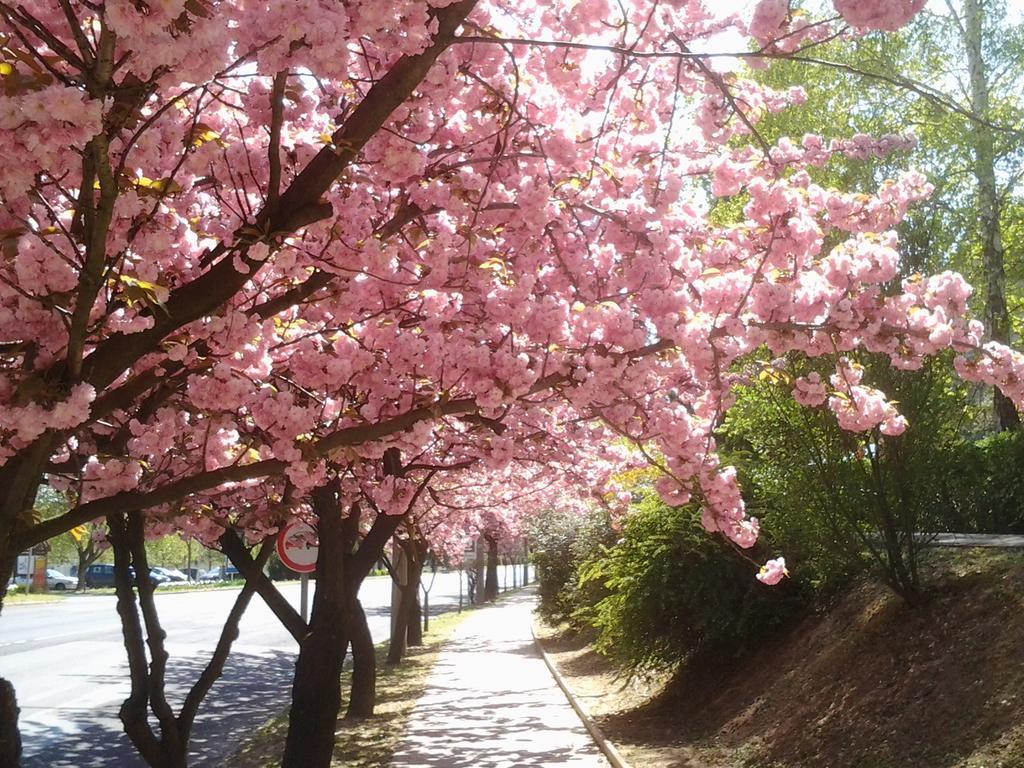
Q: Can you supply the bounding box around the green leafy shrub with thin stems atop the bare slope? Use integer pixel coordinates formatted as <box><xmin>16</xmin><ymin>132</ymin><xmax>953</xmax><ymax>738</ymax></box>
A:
<box><xmin>722</xmin><ymin>355</ymin><xmax>973</xmax><ymax>602</ymax></box>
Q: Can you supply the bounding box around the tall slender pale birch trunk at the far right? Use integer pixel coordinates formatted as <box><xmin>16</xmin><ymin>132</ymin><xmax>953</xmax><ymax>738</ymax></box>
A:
<box><xmin>964</xmin><ymin>0</ymin><xmax>1021</xmax><ymax>431</ymax></box>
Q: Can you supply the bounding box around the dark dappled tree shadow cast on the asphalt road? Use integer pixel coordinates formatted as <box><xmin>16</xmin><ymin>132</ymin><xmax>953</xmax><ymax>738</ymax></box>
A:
<box><xmin>23</xmin><ymin>651</ymin><xmax>295</xmax><ymax>768</ymax></box>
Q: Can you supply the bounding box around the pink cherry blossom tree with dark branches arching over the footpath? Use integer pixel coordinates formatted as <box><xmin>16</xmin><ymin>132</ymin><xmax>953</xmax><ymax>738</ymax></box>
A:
<box><xmin>0</xmin><ymin>0</ymin><xmax>1024</xmax><ymax>766</ymax></box>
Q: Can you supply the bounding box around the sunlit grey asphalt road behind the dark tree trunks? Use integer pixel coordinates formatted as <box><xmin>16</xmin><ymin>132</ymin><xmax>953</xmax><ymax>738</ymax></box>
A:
<box><xmin>0</xmin><ymin>569</ymin><xmax>521</xmax><ymax>768</ymax></box>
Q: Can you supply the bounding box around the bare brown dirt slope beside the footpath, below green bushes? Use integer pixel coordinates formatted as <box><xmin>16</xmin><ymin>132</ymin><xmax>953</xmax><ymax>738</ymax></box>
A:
<box><xmin>540</xmin><ymin>550</ymin><xmax>1024</xmax><ymax>768</ymax></box>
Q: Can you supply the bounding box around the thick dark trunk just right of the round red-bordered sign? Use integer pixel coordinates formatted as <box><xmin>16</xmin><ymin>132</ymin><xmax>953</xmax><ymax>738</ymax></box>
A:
<box><xmin>281</xmin><ymin>484</ymin><xmax>350</xmax><ymax>768</ymax></box>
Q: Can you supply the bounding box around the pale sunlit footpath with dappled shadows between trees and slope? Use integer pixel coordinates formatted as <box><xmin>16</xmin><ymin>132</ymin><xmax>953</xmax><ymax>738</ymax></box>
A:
<box><xmin>392</xmin><ymin>589</ymin><xmax>608</xmax><ymax>768</ymax></box>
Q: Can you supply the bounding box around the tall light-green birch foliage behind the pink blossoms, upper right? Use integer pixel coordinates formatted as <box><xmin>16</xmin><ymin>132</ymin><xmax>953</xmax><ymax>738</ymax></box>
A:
<box><xmin>751</xmin><ymin>0</ymin><xmax>1024</xmax><ymax>430</ymax></box>
